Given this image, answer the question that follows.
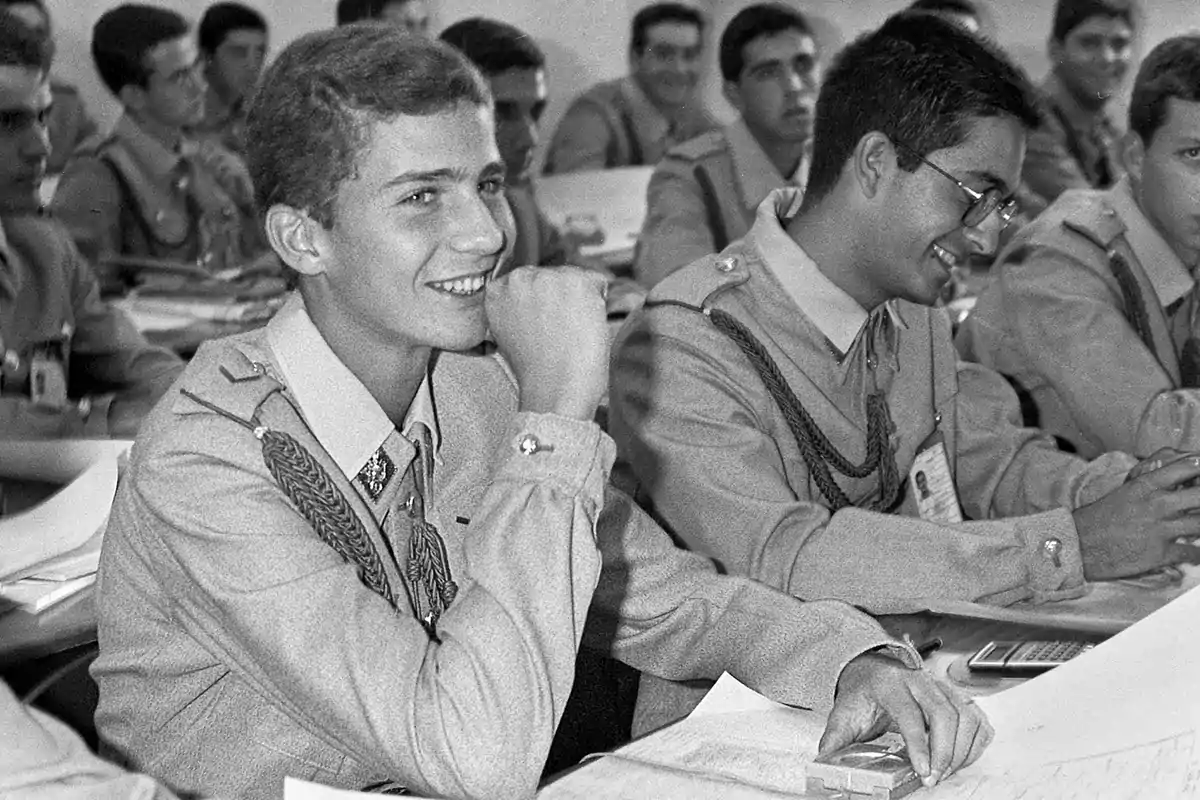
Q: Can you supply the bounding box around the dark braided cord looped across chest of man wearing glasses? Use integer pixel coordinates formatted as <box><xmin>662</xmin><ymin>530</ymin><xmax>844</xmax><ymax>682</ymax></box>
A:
<box><xmin>704</xmin><ymin>308</ymin><xmax>900</xmax><ymax>511</ymax></box>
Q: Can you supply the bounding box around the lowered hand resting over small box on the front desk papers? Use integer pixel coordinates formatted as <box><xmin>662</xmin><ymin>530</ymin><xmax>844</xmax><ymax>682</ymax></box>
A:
<box><xmin>820</xmin><ymin>652</ymin><xmax>994</xmax><ymax>786</ymax></box>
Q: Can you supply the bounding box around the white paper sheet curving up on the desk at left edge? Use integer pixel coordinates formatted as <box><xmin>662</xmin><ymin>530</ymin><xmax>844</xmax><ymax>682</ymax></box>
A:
<box><xmin>0</xmin><ymin>452</ymin><xmax>116</xmax><ymax>581</ymax></box>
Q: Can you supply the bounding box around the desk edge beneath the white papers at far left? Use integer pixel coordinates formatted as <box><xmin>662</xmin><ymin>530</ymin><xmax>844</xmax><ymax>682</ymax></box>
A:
<box><xmin>0</xmin><ymin>587</ymin><xmax>96</xmax><ymax>670</ymax></box>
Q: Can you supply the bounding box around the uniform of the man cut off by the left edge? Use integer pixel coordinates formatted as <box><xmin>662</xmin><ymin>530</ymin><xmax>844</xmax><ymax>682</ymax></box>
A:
<box><xmin>0</xmin><ymin>216</ymin><xmax>184</xmax><ymax>439</ymax></box>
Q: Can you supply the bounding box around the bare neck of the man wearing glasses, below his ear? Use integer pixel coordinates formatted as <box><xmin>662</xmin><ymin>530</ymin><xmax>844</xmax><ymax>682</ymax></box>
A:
<box><xmin>786</xmin><ymin>196</ymin><xmax>887</xmax><ymax>312</ymax></box>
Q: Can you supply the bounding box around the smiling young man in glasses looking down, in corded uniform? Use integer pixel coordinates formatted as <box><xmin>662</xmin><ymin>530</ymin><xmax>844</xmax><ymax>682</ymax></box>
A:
<box><xmin>610</xmin><ymin>14</ymin><xmax>1200</xmax><ymax>666</ymax></box>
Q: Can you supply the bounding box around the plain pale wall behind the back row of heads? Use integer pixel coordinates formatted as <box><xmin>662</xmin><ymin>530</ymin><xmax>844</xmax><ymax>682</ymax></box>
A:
<box><xmin>46</xmin><ymin>0</ymin><xmax>1200</xmax><ymax>169</ymax></box>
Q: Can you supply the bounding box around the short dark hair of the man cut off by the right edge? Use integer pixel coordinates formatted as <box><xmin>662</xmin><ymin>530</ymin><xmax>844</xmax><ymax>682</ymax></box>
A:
<box><xmin>1129</xmin><ymin>34</ymin><xmax>1200</xmax><ymax>145</ymax></box>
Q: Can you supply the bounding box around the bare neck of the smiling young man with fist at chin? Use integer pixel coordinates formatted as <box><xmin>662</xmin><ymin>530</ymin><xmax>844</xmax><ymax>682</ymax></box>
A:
<box><xmin>305</xmin><ymin>287</ymin><xmax>433</xmax><ymax>428</ymax></box>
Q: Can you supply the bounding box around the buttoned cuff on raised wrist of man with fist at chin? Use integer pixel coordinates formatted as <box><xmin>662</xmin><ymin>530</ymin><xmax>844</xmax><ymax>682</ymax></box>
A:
<box><xmin>496</xmin><ymin>411</ymin><xmax>617</xmax><ymax>503</ymax></box>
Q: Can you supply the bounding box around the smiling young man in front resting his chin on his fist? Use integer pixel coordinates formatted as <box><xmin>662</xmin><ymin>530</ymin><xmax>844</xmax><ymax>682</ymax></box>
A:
<box><xmin>92</xmin><ymin>24</ymin><xmax>990</xmax><ymax>799</ymax></box>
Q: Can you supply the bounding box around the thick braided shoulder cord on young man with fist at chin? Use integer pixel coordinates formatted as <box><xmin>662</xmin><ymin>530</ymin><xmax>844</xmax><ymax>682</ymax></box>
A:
<box><xmin>180</xmin><ymin>389</ymin><xmax>400</xmax><ymax>610</ymax></box>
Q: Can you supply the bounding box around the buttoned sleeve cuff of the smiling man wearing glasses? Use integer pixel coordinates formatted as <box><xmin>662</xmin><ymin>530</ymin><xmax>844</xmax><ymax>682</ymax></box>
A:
<box><xmin>1012</xmin><ymin>509</ymin><xmax>1084</xmax><ymax>603</ymax></box>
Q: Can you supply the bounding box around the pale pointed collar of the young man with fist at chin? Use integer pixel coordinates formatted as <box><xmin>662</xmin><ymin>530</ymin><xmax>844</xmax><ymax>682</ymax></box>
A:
<box><xmin>266</xmin><ymin>293</ymin><xmax>440</xmax><ymax>479</ymax></box>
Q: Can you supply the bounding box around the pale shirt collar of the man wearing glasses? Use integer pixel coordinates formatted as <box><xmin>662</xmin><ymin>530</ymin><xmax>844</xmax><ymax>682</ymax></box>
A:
<box><xmin>746</xmin><ymin>190</ymin><xmax>905</xmax><ymax>354</ymax></box>
